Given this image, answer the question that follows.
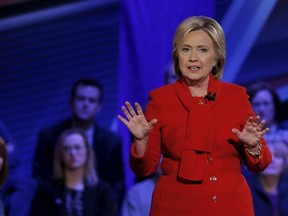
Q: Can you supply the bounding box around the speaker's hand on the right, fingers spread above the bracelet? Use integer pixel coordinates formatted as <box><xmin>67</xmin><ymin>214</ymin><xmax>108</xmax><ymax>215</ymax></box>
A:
<box><xmin>232</xmin><ymin>116</ymin><xmax>269</xmax><ymax>148</ymax></box>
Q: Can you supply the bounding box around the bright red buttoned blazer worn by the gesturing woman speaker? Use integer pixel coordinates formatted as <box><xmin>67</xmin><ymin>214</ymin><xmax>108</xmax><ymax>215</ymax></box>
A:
<box><xmin>130</xmin><ymin>75</ymin><xmax>271</xmax><ymax>216</ymax></box>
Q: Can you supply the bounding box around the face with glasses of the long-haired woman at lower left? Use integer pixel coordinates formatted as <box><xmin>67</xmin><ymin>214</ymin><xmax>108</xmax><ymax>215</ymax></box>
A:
<box><xmin>62</xmin><ymin>133</ymin><xmax>87</xmax><ymax>170</ymax></box>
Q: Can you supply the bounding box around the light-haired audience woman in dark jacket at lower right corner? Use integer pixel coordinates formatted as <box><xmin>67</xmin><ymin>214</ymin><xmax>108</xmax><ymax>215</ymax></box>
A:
<box><xmin>246</xmin><ymin>142</ymin><xmax>288</xmax><ymax>216</ymax></box>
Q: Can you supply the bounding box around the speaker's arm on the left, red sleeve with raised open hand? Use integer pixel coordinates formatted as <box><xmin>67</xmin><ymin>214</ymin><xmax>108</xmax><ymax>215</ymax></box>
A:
<box><xmin>119</xmin><ymin>95</ymin><xmax>161</xmax><ymax>176</ymax></box>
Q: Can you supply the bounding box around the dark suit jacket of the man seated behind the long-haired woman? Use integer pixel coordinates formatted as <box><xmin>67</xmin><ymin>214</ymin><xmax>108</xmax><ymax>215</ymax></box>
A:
<box><xmin>33</xmin><ymin>119</ymin><xmax>125</xmax><ymax>202</ymax></box>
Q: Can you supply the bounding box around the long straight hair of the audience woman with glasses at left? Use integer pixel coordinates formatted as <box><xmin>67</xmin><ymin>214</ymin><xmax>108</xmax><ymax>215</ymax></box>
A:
<box><xmin>53</xmin><ymin>128</ymin><xmax>99</xmax><ymax>186</ymax></box>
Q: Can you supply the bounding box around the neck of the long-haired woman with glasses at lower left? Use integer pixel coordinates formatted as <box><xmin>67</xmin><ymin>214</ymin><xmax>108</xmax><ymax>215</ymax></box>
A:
<box><xmin>65</xmin><ymin>169</ymin><xmax>84</xmax><ymax>190</ymax></box>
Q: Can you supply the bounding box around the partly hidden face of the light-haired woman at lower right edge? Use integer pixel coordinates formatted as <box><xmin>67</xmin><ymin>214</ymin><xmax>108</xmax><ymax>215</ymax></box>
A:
<box><xmin>262</xmin><ymin>143</ymin><xmax>284</xmax><ymax>176</ymax></box>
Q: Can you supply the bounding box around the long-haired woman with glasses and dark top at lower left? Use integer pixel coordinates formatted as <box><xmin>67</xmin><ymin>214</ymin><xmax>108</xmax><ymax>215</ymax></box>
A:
<box><xmin>31</xmin><ymin>129</ymin><xmax>116</xmax><ymax>216</ymax></box>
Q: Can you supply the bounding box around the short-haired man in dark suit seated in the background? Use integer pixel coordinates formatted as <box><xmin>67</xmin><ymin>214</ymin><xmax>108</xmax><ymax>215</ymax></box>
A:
<box><xmin>33</xmin><ymin>79</ymin><xmax>125</xmax><ymax>208</ymax></box>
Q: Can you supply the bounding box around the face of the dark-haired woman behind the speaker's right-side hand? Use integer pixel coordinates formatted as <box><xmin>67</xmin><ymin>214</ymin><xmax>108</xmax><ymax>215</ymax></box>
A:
<box><xmin>251</xmin><ymin>89</ymin><xmax>275</xmax><ymax>126</ymax></box>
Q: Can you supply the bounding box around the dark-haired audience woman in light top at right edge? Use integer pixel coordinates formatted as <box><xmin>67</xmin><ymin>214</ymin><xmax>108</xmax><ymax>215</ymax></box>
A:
<box><xmin>248</xmin><ymin>82</ymin><xmax>288</xmax><ymax>147</ymax></box>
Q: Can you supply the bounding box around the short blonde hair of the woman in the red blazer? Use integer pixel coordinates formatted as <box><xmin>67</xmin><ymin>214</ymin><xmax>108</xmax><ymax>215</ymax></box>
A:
<box><xmin>172</xmin><ymin>16</ymin><xmax>226</xmax><ymax>80</ymax></box>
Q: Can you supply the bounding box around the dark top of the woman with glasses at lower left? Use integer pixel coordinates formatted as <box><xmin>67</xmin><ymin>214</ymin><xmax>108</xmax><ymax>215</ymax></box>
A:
<box><xmin>30</xmin><ymin>181</ymin><xmax>116</xmax><ymax>216</ymax></box>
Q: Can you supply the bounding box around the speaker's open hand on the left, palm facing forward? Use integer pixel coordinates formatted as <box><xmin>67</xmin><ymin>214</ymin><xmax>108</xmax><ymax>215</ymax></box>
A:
<box><xmin>118</xmin><ymin>101</ymin><xmax>157</xmax><ymax>140</ymax></box>
